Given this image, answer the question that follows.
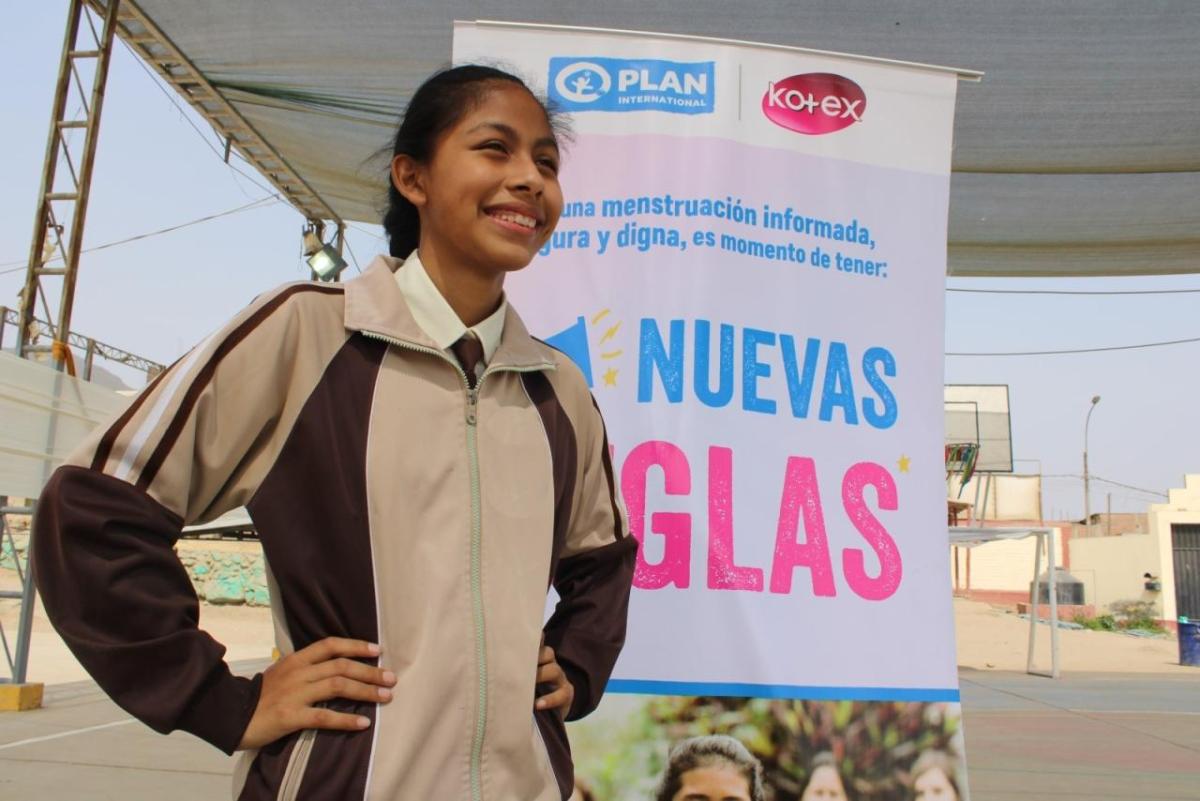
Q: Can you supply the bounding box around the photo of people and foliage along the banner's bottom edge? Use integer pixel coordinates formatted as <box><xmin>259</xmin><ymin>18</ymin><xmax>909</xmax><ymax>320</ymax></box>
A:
<box><xmin>569</xmin><ymin>695</ymin><xmax>966</xmax><ymax>801</ymax></box>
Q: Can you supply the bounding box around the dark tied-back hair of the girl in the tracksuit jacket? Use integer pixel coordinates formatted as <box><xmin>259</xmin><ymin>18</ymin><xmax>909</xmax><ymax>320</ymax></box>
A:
<box><xmin>383</xmin><ymin>64</ymin><xmax>554</xmax><ymax>259</ymax></box>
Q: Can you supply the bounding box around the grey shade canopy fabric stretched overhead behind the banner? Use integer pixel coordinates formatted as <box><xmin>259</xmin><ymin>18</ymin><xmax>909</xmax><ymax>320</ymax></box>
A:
<box><xmin>136</xmin><ymin>0</ymin><xmax>1200</xmax><ymax>276</ymax></box>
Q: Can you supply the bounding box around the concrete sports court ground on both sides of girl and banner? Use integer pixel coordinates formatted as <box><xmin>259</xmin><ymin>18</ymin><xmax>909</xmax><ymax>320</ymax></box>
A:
<box><xmin>0</xmin><ymin>662</ymin><xmax>1200</xmax><ymax>801</ymax></box>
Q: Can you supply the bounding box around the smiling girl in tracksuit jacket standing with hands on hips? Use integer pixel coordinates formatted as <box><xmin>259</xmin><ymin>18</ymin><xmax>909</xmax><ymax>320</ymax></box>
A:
<box><xmin>35</xmin><ymin>66</ymin><xmax>636</xmax><ymax>801</ymax></box>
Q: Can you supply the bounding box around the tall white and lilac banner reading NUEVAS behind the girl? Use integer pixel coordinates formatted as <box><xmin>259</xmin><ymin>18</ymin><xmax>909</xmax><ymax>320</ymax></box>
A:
<box><xmin>454</xmin><ymin>23</ymin><xmax>967</xmax><ymax>801</ymax></box>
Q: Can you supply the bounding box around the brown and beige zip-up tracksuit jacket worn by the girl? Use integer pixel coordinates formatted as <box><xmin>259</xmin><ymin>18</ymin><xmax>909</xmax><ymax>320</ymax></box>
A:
<box><xmin>34</xmin><ymin>257</ymin><xmax>636</xmax><ymax>801</ymax></box>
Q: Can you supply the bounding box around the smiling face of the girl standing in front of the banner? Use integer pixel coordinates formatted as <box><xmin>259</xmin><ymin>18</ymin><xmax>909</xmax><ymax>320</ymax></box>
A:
<box><xmin>392</xmin><ymin>82</ymin><xmax>563</xmax><ymax>276</ymax></box>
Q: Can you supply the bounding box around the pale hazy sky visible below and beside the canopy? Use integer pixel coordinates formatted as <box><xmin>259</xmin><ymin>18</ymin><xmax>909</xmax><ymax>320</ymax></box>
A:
<box><xmin>0</xmin><ymin>0</ymin><xmax>1200</xmax><ymax>519</ymax></box>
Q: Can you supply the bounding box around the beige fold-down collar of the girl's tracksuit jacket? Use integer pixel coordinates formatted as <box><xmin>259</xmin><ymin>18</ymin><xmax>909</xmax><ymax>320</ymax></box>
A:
<box><xmin>346</xmin><ymin>255</ymin><xmax>554</xmax><ymax>369</ymax></box>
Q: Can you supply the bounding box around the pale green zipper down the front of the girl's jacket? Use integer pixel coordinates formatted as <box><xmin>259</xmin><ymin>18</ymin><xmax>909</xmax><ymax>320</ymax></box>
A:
<box><xmin>362</xmin><ymin>331</ymin><xmax>550</xmax><ymax>801</ymax></box>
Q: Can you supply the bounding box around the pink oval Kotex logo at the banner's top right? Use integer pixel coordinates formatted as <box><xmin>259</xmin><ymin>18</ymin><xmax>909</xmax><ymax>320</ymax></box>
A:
<box><xmin>762</xmin><ymin>72</ymin><xmax>866</xmax><ymax>135</ymax></box>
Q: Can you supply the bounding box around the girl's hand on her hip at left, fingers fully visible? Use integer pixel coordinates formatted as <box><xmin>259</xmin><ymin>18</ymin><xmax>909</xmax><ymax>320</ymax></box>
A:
<box><xmin>238</xmin><ymin>637</ymin><xmax>396</xmax><ymax>748</ymax></box>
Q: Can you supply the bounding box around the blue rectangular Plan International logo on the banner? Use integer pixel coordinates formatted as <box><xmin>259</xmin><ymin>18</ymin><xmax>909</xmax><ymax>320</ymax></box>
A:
<box><xmin>547</xmin><ymin>56</ymin><xmax>715</xmax><ymax>114</ymax></box>
